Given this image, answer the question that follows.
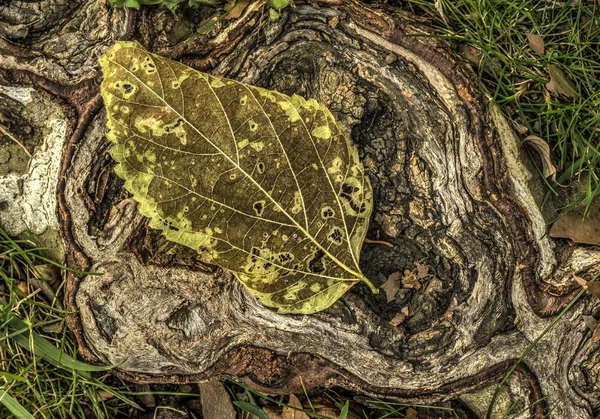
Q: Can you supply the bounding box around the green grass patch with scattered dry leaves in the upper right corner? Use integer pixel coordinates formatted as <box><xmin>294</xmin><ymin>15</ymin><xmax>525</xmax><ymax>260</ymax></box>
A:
<box><xmin>407</xmin><ymin>0</ymin><xmax>600</xmax><ymax>217</ymax></box>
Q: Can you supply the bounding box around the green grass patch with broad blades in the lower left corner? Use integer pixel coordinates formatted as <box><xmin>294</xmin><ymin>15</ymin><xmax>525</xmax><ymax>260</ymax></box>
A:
<box><xmin>0</xmin><ymin>229</ymin><xmax>140</xmax><ymax>418</ymax></box>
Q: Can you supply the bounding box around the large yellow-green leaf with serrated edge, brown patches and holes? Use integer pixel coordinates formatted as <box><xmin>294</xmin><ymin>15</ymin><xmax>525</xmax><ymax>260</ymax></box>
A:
<box><xmin>100</xmin><ymin>42</ymin><xmax>377</xmax><ymax>313</ymax></box>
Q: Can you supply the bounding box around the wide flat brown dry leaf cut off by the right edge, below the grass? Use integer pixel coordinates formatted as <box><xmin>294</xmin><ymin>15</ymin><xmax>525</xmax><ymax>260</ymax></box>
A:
<box><xmin>550</xmin><ymin>205</ymin><xmax>600</xmax><ymax>245</ymax></box>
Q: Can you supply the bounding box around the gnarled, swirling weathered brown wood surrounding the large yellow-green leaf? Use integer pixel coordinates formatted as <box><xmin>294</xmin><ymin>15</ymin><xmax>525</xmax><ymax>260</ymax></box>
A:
<box><xmin>0</xmin><ymin>0</ymin><xmax>600</xmax><ymax>418</ymax></box>
